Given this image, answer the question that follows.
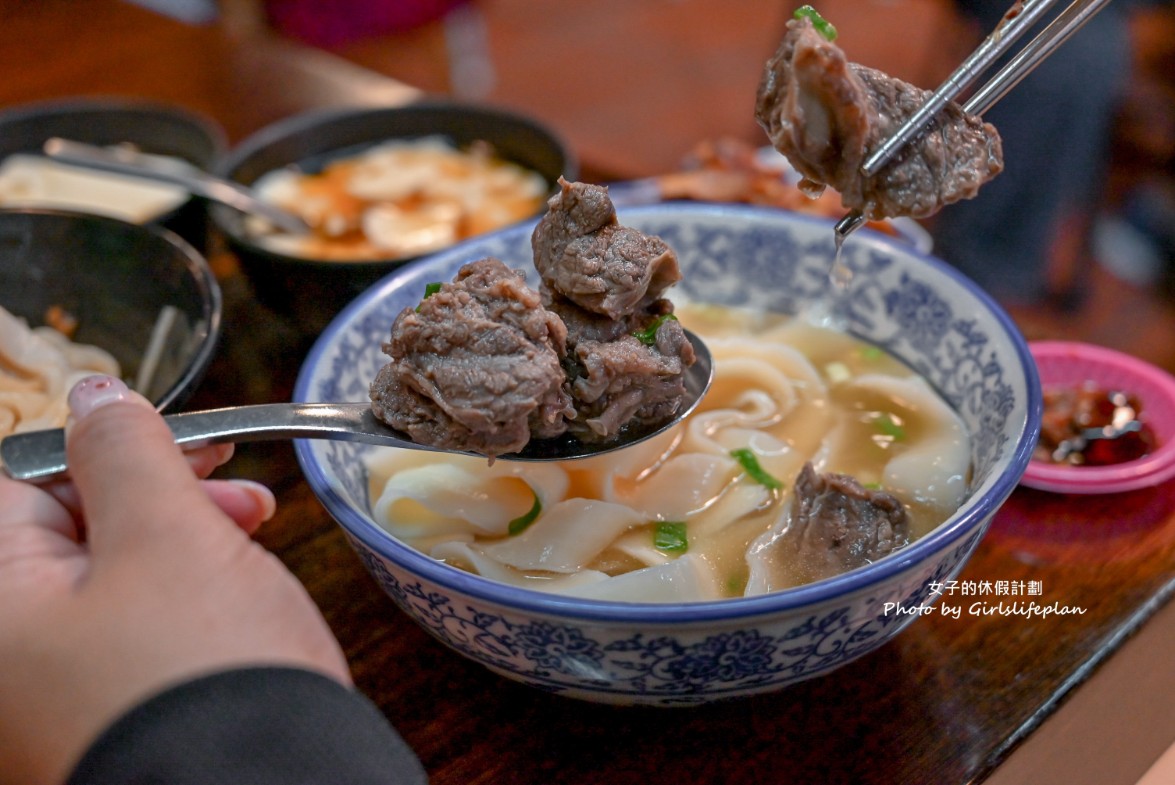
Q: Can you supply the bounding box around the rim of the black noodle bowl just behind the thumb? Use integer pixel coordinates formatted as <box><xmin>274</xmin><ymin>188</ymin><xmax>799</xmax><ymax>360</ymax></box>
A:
<box><xmin>0</xmin><ymin>207</ymin><xmax>224</xmax><ymax>411</ymax></box>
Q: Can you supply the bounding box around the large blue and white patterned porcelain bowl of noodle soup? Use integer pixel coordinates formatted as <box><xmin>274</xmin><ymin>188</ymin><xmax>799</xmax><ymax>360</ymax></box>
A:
<box><xmin>295</xmin><ymin>203</ymin><xmax>1041</xmax><ymax>706</ymax></box>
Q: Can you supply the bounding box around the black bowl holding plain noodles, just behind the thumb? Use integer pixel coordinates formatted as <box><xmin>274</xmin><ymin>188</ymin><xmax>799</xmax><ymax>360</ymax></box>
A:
<box><xmin>0</xmin><ymin>208</ymin><xmax>221</xmax><ymax>411</ymax></box>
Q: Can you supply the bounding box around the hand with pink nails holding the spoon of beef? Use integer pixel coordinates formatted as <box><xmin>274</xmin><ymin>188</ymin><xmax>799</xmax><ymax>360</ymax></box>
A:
<box><xmin>0</xmin><ymin>376</ymin><xmax>350</xmax><ymax>783</ymax></box>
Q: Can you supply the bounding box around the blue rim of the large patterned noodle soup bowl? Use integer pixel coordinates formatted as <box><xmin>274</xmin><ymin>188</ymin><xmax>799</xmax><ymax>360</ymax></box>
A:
<box><xmin>294</xmin><ymin>202</ymin><xmax>1041</xmax><ymax>626</ymax></box>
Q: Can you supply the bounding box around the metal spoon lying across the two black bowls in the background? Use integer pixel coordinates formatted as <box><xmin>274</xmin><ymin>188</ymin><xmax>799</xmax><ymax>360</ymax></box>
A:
<box><xmin>42</xmin><ymin>137</ymin><xmax>310</xmax><ymax>234</ymax></box>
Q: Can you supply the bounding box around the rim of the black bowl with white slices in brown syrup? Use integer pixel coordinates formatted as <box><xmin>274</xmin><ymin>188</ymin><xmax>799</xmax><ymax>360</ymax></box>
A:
<box><xmin>208</xmin><ymin>98</ymin><xmax>579</xmax><ymax>270</ymax></box>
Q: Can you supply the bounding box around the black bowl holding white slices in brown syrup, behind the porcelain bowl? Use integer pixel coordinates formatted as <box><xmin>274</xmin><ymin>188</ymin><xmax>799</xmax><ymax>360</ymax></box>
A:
<box><xmin>212</xmin><ymin>101</ymin><xmax>578</xmax><ymax>335</ymax></box>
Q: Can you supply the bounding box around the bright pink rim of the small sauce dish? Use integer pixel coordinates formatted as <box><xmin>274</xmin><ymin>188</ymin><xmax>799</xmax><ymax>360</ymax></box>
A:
<box><xmin>1020</xmin><ymin>341</ymin><xmax>1175</xmax><ymax>494</ymax></box>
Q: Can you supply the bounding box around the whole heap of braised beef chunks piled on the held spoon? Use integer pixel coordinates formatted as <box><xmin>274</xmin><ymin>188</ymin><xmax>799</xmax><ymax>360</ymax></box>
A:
<box><xmin>370</xmin><ymin>180</ymin><xmax>696</xmax><ymax>457</ymax></box>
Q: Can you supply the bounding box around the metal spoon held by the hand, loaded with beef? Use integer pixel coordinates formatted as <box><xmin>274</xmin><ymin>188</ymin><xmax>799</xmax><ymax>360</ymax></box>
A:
<box><xmin>0</xmin><ymin>331</ymin><xmax>714</xmax><ymax>481</ymax></box>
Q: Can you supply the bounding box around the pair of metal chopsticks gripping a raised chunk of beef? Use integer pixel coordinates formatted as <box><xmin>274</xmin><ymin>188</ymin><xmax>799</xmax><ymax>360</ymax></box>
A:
<box><xmin>835</xmin><ymin>0</ymin><xmax>1109</xmax><ymax>237</ymax></box>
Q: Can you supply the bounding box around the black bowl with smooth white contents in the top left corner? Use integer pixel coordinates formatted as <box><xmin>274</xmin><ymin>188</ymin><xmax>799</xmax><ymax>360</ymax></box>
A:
<box><xmin>0</xmin><ymin>98</ymin><xmax>228</xmax><ymax>251</ymax></box>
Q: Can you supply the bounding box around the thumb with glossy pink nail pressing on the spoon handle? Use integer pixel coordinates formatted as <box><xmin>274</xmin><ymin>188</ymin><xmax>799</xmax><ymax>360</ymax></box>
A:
<box><xmin>66</xmin><ymin>376</ymin><xmax>231</xmax><ymax>556</ymax></box>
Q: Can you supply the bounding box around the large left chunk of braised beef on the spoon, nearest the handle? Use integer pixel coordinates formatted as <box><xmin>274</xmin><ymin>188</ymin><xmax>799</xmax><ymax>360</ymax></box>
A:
<box><xmin>370</xmin><ymin>259</ymin><xmax>575</xmax><ymax>457</ymax></box>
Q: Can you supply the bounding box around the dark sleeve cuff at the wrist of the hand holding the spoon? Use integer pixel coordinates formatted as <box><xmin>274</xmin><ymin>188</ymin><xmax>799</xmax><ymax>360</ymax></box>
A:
<box><xmin>68</xmin><ymin>667</ymin><xmax>428</xmax><ymax>785</ymax></box>
